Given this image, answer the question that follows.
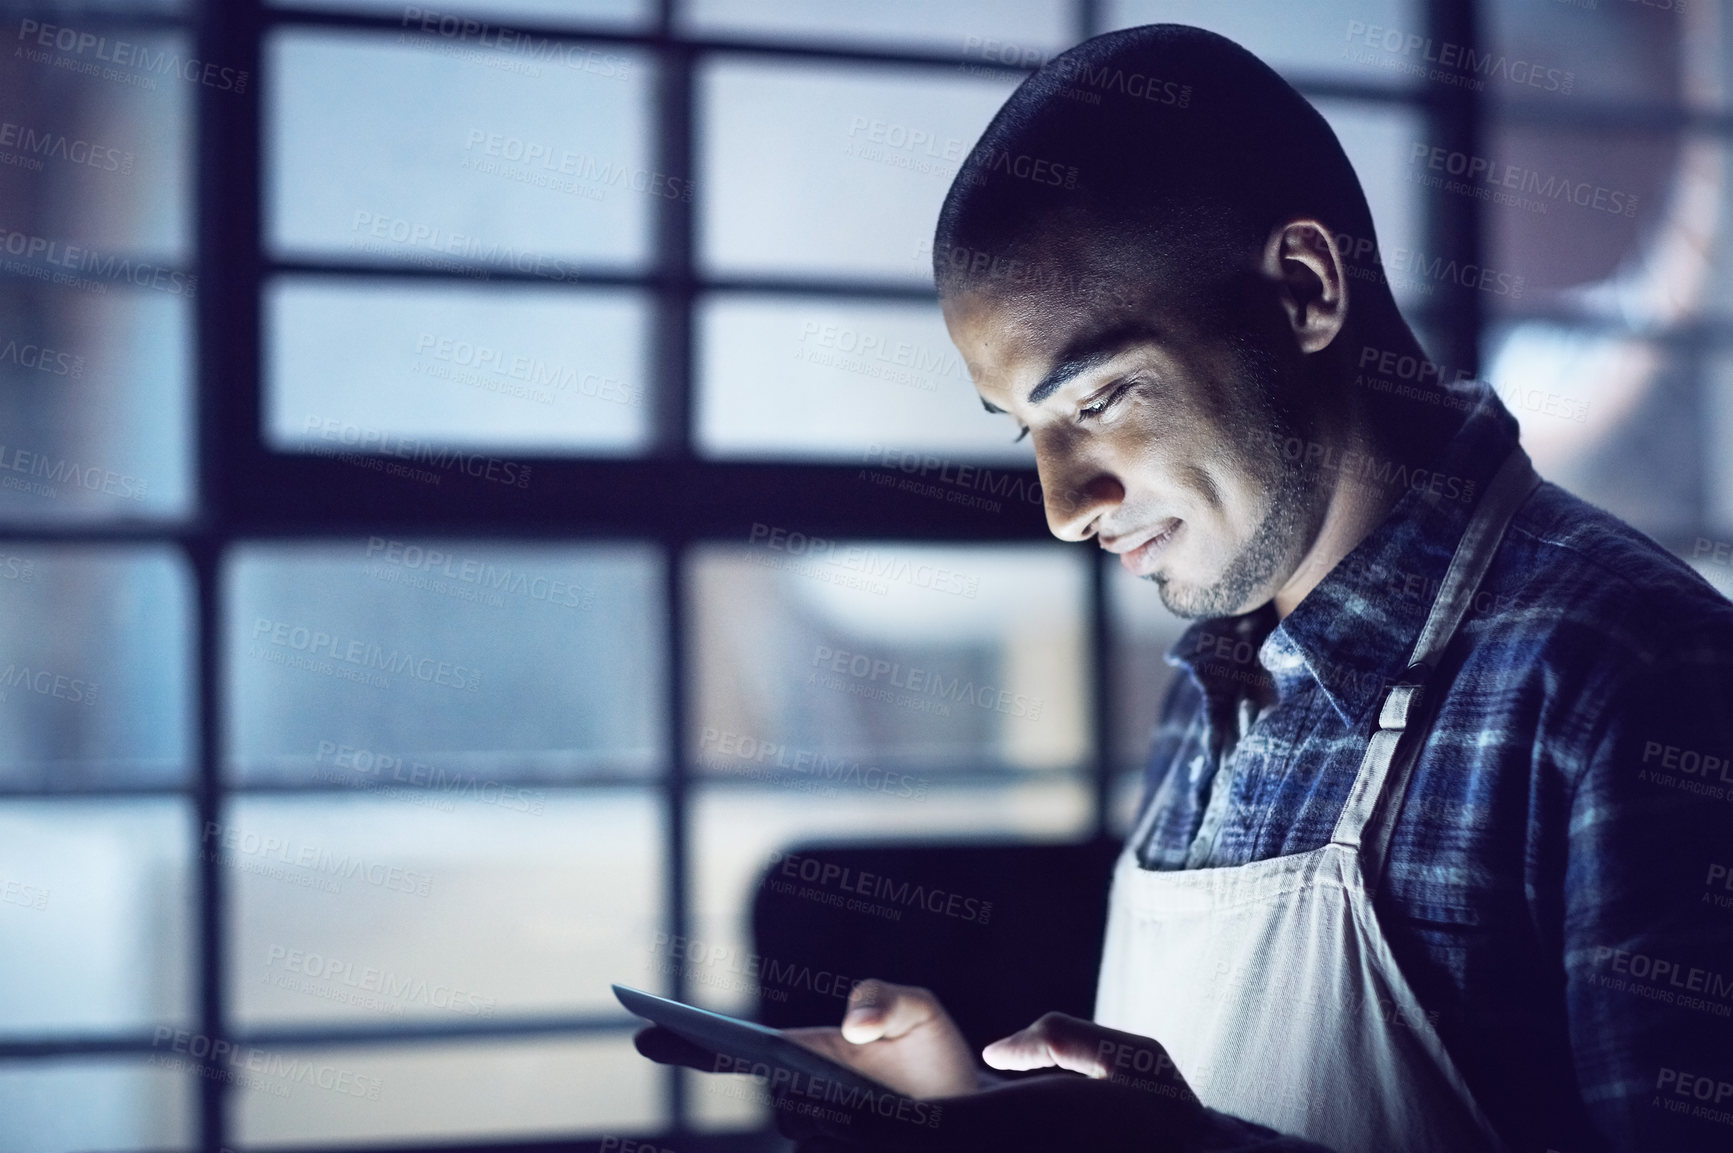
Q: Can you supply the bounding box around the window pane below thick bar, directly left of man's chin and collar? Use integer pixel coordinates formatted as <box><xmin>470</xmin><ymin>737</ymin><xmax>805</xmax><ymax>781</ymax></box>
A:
<box><xmin>690</xmin><ymin>531</ymin><xmax>1088</xmax><ymax>773</ymax></box>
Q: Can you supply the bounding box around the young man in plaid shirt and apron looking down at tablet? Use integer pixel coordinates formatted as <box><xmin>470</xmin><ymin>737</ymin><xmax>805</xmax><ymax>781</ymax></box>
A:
<box><xmin>645</xmin><ymin>26</ymin><xmax>1733</xmax><ymax>1153</ymax></box>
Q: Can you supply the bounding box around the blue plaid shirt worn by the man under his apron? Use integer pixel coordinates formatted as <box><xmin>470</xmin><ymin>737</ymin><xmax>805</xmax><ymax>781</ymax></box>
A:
<box><xmin>1137</xmin><ymin>385</ymin><xmax>1733</xmax><ymax>1153</ymax></box>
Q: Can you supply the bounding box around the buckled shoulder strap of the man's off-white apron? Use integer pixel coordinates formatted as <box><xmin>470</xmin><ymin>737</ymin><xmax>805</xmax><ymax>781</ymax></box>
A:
<box><xmin>1329</xmin><ymin>447</ymin><xmax>1541</xmax><ymax>893</ymax></box>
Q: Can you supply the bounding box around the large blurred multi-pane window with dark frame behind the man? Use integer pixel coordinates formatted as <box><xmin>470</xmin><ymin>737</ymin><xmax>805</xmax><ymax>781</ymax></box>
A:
<box><xmin>0</xmin><ymin>0</ymin><xmax>1733</xmax><ymax>1153</ymax></box>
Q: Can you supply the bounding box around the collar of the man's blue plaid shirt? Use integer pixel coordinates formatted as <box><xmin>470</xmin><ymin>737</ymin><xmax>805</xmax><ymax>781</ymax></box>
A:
<box><xmin>1166</xmin><ymin>372</ymin><xmax>1516</xmax><ymax>725</ymax></box>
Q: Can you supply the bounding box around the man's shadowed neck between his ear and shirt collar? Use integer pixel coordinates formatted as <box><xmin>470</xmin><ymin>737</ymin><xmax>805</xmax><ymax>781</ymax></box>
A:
<box><xmin>1274</xmin><ymin>317</ymin><xmax>1456</xmax><ymax>617</ymax></box>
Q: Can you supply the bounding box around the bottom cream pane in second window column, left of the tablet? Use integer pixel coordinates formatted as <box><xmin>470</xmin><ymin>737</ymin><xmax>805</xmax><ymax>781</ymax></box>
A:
<box><xmin>232</xmin><ymin>1033</ymin><xmax>665</xmax><ymax>1150</ymax></box>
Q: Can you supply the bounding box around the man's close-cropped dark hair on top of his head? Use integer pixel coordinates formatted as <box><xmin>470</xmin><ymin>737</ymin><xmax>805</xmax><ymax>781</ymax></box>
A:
<box><xmin>932</xmin><ymin>24</ymin><xmax>1393</xmax><ymax>317</ymax></box>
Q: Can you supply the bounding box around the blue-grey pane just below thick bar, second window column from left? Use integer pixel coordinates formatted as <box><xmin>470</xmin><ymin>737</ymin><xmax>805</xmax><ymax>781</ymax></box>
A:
<box><xmin>225</xmin><ymin>536</ymin><xmax>664</xmax><ymax>784</ymax></box>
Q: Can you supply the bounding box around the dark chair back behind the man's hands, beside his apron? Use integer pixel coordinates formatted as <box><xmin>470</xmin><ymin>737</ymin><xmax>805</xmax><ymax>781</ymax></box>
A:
<box><xmin>752</xmin><ymin>841</ymin><xmax>1118</xmax><ymax>1049</ymax></box>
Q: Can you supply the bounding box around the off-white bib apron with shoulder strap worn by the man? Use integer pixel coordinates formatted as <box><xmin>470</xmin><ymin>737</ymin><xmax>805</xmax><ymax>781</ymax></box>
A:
<box><xmin>1095</xmin><ymin>449</ymin><xmax>1539</xmax><ymax>1153</ymax></box>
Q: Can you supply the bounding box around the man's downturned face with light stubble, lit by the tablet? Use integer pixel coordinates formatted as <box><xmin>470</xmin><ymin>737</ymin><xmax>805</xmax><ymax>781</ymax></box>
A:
<box><xmin>944</xmin><ymin>293</ymin><xmax>1324</xmax><ymax>617</ymax></box>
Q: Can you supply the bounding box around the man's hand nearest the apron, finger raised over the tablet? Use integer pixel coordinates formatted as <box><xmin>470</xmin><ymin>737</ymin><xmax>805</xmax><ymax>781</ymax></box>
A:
<box><xmin>783</xmin><ymin>1013</ymin><xmax>1206</xmax><ymax>1153</ymax></box>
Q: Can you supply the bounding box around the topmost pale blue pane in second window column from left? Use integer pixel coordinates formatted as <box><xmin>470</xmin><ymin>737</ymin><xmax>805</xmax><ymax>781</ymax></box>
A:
<box><xmin>265</xmin><ymin>29</ymin><xmax>651</xmax><ymax>267</ymax></box>
